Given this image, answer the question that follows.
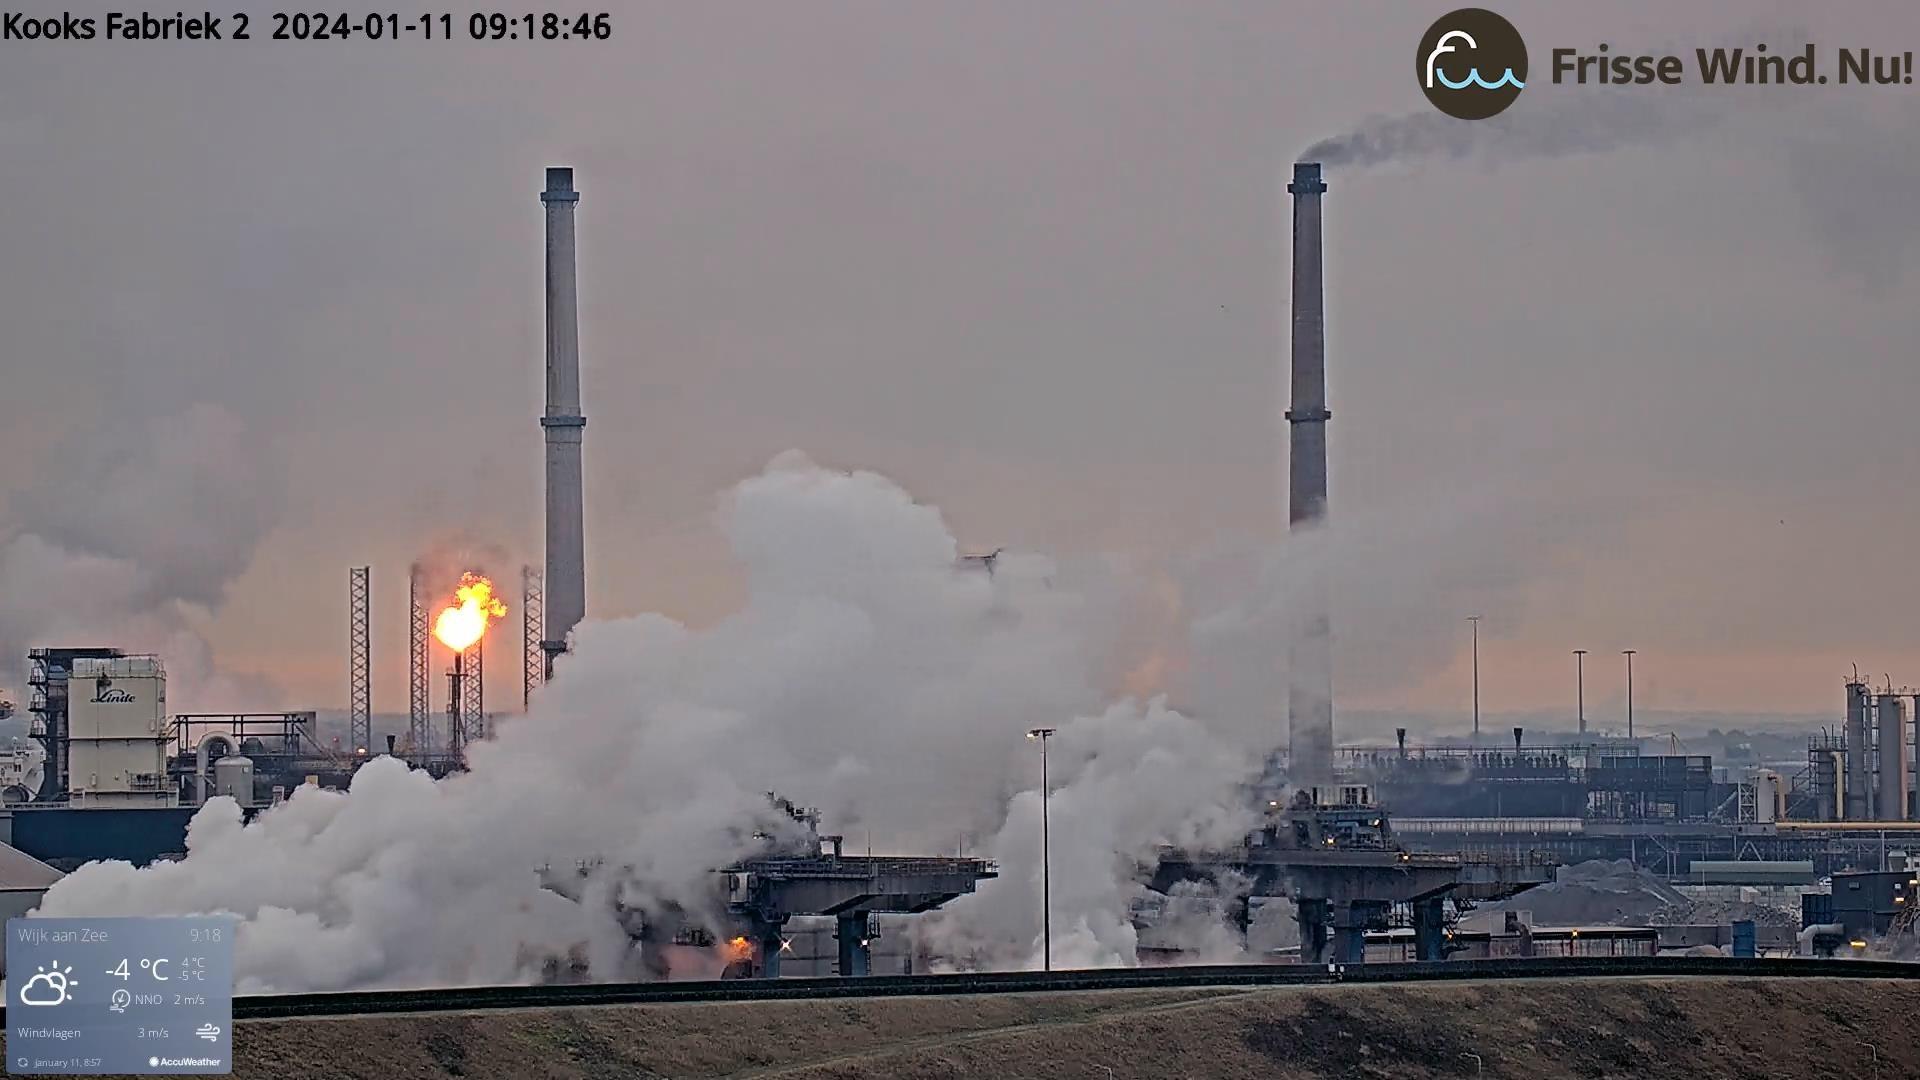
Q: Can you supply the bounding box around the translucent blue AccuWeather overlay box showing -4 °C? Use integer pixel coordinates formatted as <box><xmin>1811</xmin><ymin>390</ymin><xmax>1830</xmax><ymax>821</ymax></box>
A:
<box><xmin>6</xmin><ymin>919</ymin><xmax>234</xmax><ymax>1076</ymax></box>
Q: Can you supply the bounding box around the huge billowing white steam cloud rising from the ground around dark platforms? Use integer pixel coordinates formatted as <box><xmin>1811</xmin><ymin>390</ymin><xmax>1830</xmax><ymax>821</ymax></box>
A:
<box><xmin>42</xmin><ymin>455</ymin><xmax>1254</xmax><ymax>990</ymax></box>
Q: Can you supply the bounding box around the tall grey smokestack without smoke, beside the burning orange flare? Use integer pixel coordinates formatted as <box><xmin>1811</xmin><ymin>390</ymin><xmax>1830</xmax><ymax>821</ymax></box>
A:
<box><xmin>540</xmin><ymin>169</ymin><xmax>588</xmax><ymax>678</ymax></box>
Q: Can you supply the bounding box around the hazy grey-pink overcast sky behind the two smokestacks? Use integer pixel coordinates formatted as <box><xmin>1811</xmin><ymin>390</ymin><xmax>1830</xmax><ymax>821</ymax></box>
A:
<box><xmin>0</xmin><ymin>0</ymin><xmax>1920</xmax><ymax>736</ymax></box>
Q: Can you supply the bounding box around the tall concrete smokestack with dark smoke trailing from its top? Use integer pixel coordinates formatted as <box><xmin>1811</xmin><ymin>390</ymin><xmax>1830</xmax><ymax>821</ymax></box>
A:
<box><xmin>1286</xmin><ymin>161</ymin><xmax>1332</xmax><ymax>784</ymax></box>
